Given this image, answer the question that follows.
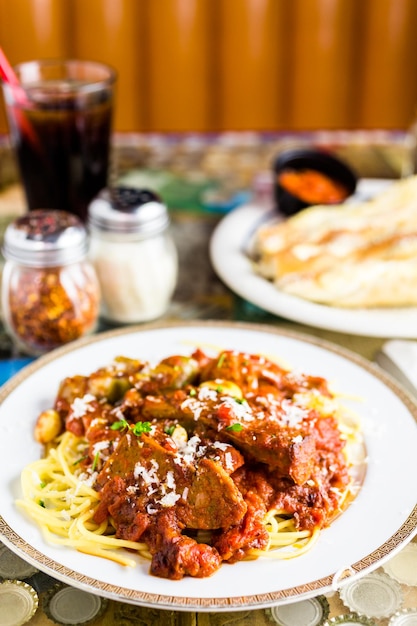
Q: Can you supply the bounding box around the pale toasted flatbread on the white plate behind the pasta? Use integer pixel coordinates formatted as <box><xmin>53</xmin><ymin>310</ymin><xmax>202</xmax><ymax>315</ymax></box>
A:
<box><xmin>254</xmin><ymin>176</ymin><xmax>417</xmax><ymax>308</ymax></box>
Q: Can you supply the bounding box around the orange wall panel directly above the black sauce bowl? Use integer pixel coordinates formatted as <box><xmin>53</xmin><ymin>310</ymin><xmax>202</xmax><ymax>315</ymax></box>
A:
<box><xmin>288</xmin><ymin>0</ymin><xmax>361</xmax><ymax>130</ymax></box>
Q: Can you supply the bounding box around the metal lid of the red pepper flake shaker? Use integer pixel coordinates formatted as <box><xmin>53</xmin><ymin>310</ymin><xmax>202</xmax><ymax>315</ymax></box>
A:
<box><xmin>2</xmin><ymin>209</ymin><xmax>88</xmax><ymax>267</ymax></box>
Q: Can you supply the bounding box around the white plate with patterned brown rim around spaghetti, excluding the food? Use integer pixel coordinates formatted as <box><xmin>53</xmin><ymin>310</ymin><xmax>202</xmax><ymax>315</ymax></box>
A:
<box><xmin>0</xmin><ymin>322</ymin><xmax>417</xmax><ymax>611</ymax></box>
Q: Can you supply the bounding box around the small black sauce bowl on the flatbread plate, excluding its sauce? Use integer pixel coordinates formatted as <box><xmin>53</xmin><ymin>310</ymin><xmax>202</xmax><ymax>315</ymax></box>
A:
<box><xmin>273</xmin><ymin>149</ymin><xmax>357</xmax><ymax>216</ymax></box>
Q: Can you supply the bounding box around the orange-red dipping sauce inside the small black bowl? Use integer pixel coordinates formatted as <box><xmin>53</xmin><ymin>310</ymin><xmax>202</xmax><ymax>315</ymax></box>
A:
<box><xmin>278</xmin><ymin>169</ymin><xmax>349</xmax><ymax>204</ymax></box>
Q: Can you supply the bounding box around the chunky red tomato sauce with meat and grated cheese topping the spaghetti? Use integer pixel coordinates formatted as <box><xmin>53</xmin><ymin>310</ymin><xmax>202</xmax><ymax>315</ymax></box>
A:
<box><xmin>49</xmin><ymin>350</ymin><xmax>350</xmax><ymax>579</ymax></box>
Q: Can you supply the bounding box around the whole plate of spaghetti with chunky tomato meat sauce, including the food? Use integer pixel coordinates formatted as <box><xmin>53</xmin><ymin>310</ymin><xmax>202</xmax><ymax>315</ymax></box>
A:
<box><xmin>0</xmin><ymin>322</ymin><xmax>417</xmax><ymax>611</ymax></box>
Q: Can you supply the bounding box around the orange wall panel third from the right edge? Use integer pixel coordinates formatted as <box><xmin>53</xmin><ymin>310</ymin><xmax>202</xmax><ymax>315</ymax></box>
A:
<box><xmin>215</xmin><ymin>0</ymin><xmax>290</xmax><ymax>130</ymax></box>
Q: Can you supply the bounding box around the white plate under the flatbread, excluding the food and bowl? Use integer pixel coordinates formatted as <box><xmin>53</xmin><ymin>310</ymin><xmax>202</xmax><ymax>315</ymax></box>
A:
<box><xmin>210</xmin><ymin>179</ymin><xmax>417</xmax><ymax>339</ymax></box>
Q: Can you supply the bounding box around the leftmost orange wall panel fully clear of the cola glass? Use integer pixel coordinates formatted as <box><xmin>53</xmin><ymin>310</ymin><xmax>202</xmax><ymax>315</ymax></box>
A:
<box><xmin>144</xmin><ymin>0</ymin><xmax>215</xmax><ymax>131</ymax></box>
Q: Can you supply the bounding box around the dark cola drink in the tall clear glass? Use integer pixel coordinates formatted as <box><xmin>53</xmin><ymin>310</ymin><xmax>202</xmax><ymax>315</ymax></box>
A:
<box><xmin>5</xmin><ymin>62</ymin><xmax>114</xmax><ymax>221</ymax></box>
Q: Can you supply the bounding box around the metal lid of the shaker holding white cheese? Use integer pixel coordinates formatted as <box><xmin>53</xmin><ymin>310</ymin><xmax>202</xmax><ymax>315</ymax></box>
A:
<box><xmin>88</xmin><ymin>187</ymin><xmax>169</xmax><ymax>237</ymax></box>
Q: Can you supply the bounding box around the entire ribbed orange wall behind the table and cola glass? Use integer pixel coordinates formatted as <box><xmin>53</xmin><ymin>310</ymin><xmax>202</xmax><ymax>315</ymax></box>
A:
<box><xmin>0</xmin><ymin>0</ymin><xmax>417</xmax><ymax>132</ymax></box>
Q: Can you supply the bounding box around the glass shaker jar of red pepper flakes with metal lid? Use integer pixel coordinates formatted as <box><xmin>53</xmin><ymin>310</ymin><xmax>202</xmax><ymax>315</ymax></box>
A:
<box><xmin>2</xmin><ymin>209</ymin><xmax>100</xmax><ymax>356</ymax></box>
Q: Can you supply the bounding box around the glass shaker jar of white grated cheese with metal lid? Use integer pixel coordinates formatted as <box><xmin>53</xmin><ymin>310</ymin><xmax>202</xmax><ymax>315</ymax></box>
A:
<box><xmin>88</xmin><ymin>187</ymin><xmax>178</xmax><ymax>324</ymax></box>
